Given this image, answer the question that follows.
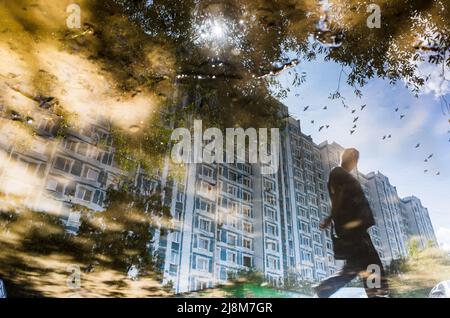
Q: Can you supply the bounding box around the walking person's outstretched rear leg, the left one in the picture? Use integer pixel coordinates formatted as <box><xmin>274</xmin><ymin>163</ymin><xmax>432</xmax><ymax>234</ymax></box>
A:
<box><xmin>314</xmin><ymin>262</ymin><xmax>359</xmax><ymax>298</ymax></box>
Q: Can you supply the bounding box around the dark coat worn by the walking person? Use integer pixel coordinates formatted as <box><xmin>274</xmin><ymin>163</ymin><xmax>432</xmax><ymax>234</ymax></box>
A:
<box><xmin>328</xmin><ymin>167</ymin><xmax>375</xmax><ymax>237</ymax></box>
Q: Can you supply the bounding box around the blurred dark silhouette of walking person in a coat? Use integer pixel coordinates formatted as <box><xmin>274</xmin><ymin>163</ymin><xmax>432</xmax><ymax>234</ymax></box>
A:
<box><xmin>314</xmin><ymin>148</ymin><xmax>388</xmax><ymax>298</ymax></box>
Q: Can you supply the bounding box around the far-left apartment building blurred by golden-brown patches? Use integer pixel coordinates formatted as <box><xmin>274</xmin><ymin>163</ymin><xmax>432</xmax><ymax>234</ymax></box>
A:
<box><xmin>0</xmin><ymin>103</ymin><xmax>124</xmax><ymax>233</ymax></box>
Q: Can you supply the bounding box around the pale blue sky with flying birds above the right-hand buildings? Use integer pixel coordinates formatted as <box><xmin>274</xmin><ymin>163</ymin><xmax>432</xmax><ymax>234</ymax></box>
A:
<box><xmin>279</xmin><ymin>58</ymin><xmax>450</xmax><ymax>250</ymax></box>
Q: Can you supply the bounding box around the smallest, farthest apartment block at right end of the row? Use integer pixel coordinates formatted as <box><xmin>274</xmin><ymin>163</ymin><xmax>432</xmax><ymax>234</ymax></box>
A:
<box><xmin>400</xmin><ymin>196</ymin><xmax>437</xmax><ymax>249</ymax></box>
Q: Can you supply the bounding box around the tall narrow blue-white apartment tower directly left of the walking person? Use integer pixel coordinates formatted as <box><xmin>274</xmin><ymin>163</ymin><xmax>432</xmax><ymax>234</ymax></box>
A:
<box><xmin>280</xmin><ymin>118</ymin><xmax>338</xmax><ymax>281</ymax></box>
